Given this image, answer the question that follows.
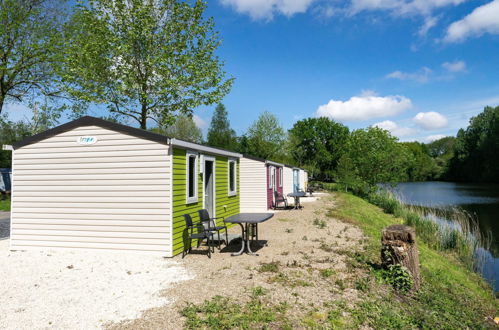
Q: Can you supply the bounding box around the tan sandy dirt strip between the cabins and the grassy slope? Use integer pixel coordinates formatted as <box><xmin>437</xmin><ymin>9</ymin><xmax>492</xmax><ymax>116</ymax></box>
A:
<box><xmin>108</xmin><ymin>195</ymin><xmax>363</xmax><ymax>329</ymax></box>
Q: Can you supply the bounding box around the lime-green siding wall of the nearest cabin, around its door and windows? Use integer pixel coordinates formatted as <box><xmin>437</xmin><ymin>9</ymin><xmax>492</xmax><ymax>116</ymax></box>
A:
<box><xmin>172</xmin><ymin>147</ymin><xmax>240</xmax><ymax>256</ymax></box>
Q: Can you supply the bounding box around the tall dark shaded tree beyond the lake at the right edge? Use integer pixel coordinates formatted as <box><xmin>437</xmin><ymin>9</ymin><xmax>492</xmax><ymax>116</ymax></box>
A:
<box><xmin>449</xmin><ymin>106</ymin><xmax>499</xmax><ymax>182</ymax></box>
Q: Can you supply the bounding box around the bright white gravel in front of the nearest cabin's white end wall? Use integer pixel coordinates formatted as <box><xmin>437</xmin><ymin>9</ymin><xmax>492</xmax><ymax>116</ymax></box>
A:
<box><xmin>0</xmin><ymin>237</ymin><xmax>192</xmax><ymax>330</ymax></box>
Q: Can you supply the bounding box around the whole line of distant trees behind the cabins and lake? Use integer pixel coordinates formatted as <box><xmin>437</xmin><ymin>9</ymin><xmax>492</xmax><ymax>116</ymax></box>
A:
<box><xmin>0</xmin><ymin>104</ymin><xmax>499</xmax><ymax>188</ymax></box>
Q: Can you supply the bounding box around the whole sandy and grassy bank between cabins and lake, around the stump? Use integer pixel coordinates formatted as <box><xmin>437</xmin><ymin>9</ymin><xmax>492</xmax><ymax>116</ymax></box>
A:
<box><xmin>109</xmin><ymin>193</ymin><xmax>499</xmax><ymax>329</ymax></box>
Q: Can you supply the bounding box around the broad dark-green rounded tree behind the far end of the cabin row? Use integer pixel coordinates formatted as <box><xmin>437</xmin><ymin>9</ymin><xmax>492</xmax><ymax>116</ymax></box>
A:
<box><xmin>289</xmin><ymin>117</ymin><xmax>349</xmax><ymax>181</ymax></box>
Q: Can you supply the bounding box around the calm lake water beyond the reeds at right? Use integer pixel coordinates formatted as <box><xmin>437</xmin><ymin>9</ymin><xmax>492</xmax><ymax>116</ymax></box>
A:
<box><xmin>395</xmin><ymin>182</ymin><xmax>499</xmax><ymax>291</ymax></box>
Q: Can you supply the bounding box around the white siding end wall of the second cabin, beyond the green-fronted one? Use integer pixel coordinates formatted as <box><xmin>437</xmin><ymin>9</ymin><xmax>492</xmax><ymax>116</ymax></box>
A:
<box><xmin>239</xmin><ymin>157</ymin><xmax>267</xmax><ymax>212</ymax></box>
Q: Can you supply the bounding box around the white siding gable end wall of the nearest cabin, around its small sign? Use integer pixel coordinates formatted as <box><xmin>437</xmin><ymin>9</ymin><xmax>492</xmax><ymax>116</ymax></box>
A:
<box><xmin>10</xmin><ymin>126</ymin><xmax>172</xmax><ymax>256</ymax></box>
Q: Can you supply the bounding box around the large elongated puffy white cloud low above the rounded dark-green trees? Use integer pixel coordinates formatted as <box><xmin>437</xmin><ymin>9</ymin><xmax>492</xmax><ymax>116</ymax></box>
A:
<box><xmin>316</xmin><ymin>91</ymin><xmax>412</xmax><ymax>121</ymax></box>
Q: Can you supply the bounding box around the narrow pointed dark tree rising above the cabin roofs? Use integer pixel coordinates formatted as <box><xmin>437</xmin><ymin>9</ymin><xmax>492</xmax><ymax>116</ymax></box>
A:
<box><xmin>207</xmin><ymin>103</ymin><xmax>237</xmax><ymax>150</ymax></box>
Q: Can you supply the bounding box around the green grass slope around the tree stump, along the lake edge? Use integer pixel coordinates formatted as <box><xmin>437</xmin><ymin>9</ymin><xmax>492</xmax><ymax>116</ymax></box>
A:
<box><xmin>330</xmin><ymin>193</ymin><xmax>499</xmax><ymax>328</ymax></box>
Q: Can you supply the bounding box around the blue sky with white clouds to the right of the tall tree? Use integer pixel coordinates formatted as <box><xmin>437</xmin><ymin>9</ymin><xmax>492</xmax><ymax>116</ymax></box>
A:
<box><xmin>3</xmin><ymin>0</ymin><xmax>499</xmax><ymax>142</ymax></box>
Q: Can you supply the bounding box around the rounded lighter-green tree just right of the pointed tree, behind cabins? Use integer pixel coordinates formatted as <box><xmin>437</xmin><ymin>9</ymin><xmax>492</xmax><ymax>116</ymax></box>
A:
<box><xmin>246</xmin><ymin>111</ymin><xmax>286</xmax><ymax>161</ymax></box>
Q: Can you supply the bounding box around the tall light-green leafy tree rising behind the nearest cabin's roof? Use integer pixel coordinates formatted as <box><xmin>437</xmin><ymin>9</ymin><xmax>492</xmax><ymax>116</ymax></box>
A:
<box><xmin>61</xmin><ymin>0</ymin><xmax>232</xmax><ymax>129</ymax></box>
